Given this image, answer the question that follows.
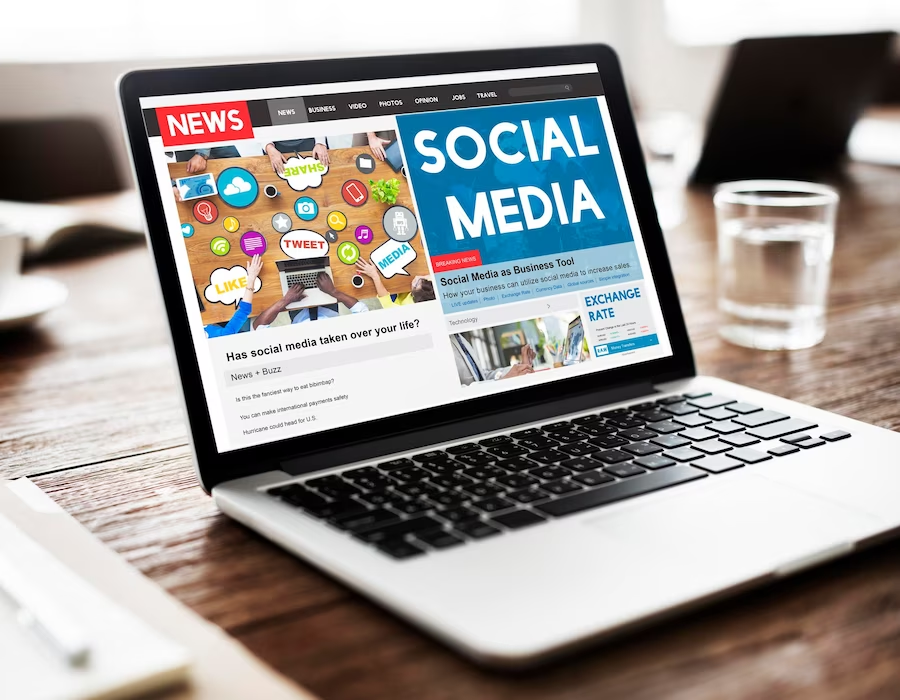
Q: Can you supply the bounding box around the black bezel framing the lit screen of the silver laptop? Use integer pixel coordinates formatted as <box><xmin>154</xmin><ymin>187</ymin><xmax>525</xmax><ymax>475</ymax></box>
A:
<box><xmin>119</xmin><ymin>45</ymin><xmax>695</xmax><ymax>491</ymax></box>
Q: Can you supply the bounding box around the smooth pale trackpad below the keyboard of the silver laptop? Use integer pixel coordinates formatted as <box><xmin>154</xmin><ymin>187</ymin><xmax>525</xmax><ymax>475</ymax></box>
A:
<box><xmin>587</xmin><ymin>470</ymin><xmax>878</xmax><ymax>584</ymax></box>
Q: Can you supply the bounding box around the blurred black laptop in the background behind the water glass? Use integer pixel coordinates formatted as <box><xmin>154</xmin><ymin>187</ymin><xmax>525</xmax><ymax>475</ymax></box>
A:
<box><xmin>692</xmin><ymin>32</ymin><xmax>896</xmax><ymax>184</ymax></box>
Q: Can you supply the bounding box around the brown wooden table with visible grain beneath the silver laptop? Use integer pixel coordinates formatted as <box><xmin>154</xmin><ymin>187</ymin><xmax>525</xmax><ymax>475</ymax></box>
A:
<box><xmin>0</xmin><ymin>165</ymin><xmax>900</xmax><ymax>700</ymax></box>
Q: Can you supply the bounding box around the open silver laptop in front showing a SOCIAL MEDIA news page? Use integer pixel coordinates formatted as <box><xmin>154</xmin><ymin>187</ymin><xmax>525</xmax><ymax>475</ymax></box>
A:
<box><xmin>120</xmin><ymin>45</ymin><xmax>900</xmax><ymax>668</ymax></box>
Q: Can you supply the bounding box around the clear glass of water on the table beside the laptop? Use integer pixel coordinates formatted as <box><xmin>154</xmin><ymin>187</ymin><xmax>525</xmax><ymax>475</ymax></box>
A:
<box><xmin>713</xmin><ymin>180</ymin><xmax>838</xmax><ymax>350</ymax></box>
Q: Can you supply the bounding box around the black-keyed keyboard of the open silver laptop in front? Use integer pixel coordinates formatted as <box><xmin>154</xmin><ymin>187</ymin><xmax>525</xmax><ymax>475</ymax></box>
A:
<box><xmin>267</xmin><ymin>392</ymin><xmax>850</xmax><ymax>559</ymax></box>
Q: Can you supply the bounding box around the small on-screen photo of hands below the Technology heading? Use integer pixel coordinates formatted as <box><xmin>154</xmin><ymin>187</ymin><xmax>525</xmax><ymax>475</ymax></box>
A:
<box><xmin>450</xmin><ymin>311</ymin><xmax>589</xmax><ymax>386</ymax></box>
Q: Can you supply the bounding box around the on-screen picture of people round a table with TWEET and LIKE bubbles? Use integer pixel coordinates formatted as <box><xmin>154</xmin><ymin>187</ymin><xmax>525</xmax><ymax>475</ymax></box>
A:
<box><xmin>167</xmin><ymin>131</ymin><xmax>435</xmax><ymax>338</ymax></box>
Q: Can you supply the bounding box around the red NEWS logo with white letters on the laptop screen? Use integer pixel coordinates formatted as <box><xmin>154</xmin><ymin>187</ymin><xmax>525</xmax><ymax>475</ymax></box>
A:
<box><xmin>156</xmin><ymin>102</ymin><xmax>253</xmax><ymax>146</ymax></box>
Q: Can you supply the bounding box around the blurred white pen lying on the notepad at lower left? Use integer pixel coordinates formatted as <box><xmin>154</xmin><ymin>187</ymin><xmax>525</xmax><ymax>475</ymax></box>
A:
<box><xmin>0</xmin><ymin>556</ymin><xmax>91</xmax><ymax>666</ymax></box>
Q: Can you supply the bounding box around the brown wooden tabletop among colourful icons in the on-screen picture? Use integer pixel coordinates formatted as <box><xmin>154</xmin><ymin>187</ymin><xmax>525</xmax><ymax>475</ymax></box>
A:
<box><xmin>169</xmin><ymin>147</ymin><xmax>429</xmax><ymax>324</ymax></box>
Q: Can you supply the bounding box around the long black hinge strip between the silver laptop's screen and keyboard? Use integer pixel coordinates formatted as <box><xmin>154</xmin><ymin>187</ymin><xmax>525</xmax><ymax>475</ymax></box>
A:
<box><xmin>280</xmin><ymin>381</ymin><xmax>656</xmax><ymax>475</ymax></box>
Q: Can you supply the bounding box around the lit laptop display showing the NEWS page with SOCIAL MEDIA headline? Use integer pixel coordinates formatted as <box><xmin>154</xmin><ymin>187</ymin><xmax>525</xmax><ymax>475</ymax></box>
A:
<box><xmin>141</xmin><ymin>64</ymin><xmax>672</xmax><ymax>452</ymax></box>
